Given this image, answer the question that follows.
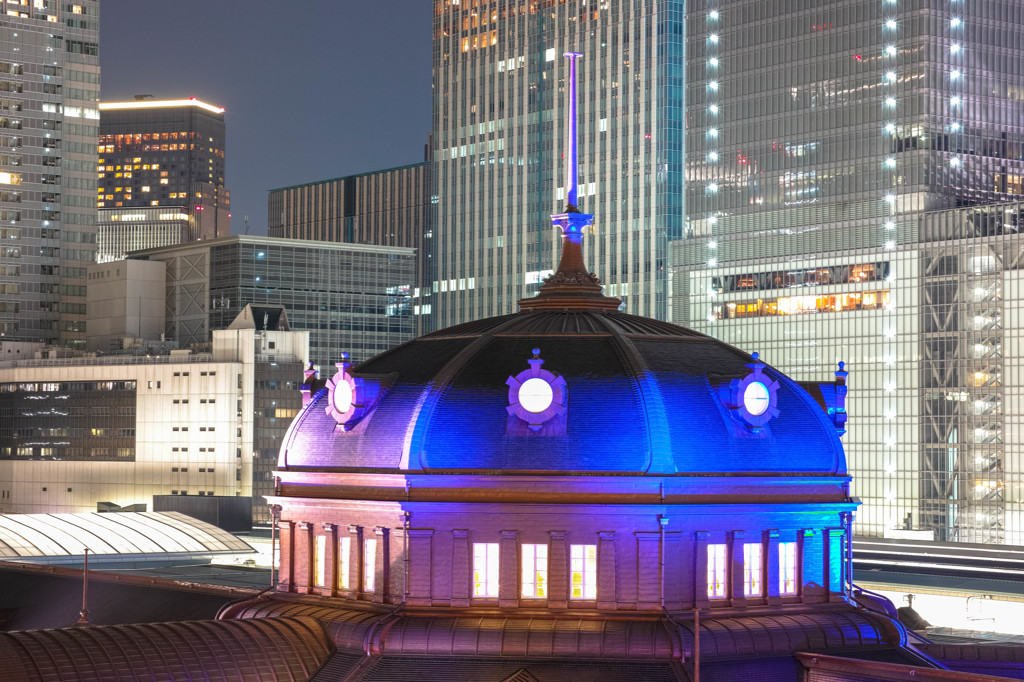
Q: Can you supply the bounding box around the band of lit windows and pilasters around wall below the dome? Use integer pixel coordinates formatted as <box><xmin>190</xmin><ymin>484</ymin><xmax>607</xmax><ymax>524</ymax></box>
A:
<box><xmin>278</xmin><ymin>521</ymin><xmax>842</xmax><ymax>605</ymax></box>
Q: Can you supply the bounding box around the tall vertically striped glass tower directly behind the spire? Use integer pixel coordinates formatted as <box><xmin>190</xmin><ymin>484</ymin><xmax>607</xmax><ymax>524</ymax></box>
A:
<box><xmin>429</xmin><ymin>0</ymin><xmax>684</xmax><ymax>327</ymax></box>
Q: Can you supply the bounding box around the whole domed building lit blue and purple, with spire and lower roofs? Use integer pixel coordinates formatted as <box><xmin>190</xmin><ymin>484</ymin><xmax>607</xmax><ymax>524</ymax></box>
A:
<box><xmin>0</xmin><ymin>54</ymin><xmax>1024</xmax><ymax>682</ymax></box>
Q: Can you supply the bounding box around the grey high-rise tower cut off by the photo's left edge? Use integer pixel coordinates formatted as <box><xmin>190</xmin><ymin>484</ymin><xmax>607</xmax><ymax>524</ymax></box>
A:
<box><xmin>0</xmin><ymin>0</ymin><xmax>99</xmax><ymax>347</ymax></box>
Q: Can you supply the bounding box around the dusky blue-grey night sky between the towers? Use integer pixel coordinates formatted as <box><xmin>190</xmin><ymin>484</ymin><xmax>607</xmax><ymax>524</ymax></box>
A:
<box><xmin>99</xmin><ymin>0</ymin><xmax>433</xmax><ymax>235</ymax></box>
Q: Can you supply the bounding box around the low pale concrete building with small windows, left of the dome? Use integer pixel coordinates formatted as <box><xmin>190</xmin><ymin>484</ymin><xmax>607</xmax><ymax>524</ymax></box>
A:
<box><xmin>0</xmin><ymin>315</ymin><xmax>308</xmax><ymax>520</ymax></box>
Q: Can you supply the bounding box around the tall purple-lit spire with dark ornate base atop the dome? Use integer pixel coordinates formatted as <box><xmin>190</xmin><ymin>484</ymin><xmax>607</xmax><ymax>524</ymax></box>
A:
<box><xmin>519</xmin><ymin>52</ymin><xmax>622</xmax><ymax>311</ymax></box>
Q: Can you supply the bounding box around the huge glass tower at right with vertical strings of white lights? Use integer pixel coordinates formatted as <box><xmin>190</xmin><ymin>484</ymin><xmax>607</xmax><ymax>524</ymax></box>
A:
<box><xmin>672</xmin><ymin>0</ymin><xmax>1024</xmax><ymax>544</ymax></box>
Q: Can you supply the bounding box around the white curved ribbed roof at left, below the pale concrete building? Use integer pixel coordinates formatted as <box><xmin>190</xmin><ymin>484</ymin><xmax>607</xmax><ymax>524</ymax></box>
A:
<box><xmin>0</xmin><ymin>512</ymin><xmax>253</xmax><ymax>561</ymax></box>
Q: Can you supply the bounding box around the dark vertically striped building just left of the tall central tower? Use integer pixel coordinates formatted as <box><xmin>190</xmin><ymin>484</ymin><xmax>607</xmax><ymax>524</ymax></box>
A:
<box><xmin>266</xmin><ymin>162</ymin><xmax>433</xmax><ymax>332</ymax></box>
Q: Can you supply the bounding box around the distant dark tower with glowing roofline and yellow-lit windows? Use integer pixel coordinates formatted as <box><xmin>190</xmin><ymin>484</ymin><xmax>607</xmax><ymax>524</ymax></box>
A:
<box><xmin>96</xmin><ymin>95</ymin><xmax>231</xmax><ymax>262</ymax></box>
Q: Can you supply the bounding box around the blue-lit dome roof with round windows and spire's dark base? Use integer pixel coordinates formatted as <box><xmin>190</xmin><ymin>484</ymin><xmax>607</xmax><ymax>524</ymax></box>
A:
<box><xmin>280</xmin><ymin>240</ymin><xmax>846</xmax><ymax>475</ymax></box>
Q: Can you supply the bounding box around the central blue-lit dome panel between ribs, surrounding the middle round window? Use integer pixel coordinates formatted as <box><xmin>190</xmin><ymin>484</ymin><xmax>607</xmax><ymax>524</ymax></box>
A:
<box><xmin>422</xmin><ymin>336</ymin><xmax>647</xmax><ymax>471</ymax></box>
